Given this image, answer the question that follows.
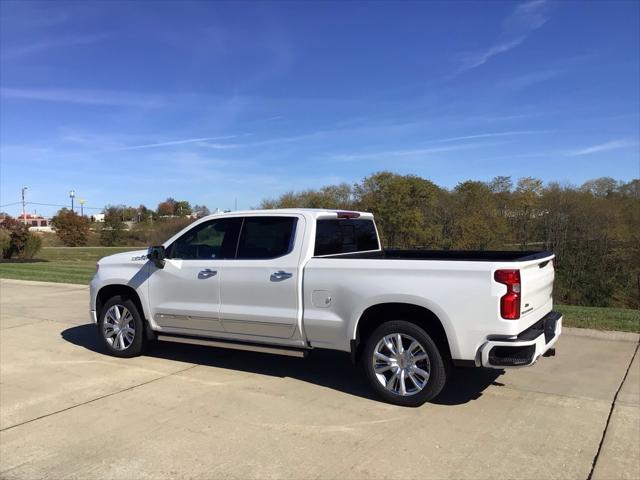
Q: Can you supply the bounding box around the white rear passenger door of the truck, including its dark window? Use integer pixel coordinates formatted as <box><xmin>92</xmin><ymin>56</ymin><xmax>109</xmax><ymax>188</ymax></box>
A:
<box><xmin>220</xmin><ymin>215</ymin><xmax>305</xmax><ymax>338</ymax></box>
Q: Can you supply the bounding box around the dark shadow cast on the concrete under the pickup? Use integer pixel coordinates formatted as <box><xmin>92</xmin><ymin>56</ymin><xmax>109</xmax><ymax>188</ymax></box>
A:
<box><xmin>61</xmin><ymin>324</ymin><xmax>504</xmax><ymax>405</ymax></box>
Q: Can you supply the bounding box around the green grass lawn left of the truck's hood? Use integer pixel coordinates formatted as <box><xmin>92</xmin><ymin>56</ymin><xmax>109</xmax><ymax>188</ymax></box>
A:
<box><xmin>0</xmin><ymin>247</ymin><xmax>141</xmax><ymax>285</ymax></box>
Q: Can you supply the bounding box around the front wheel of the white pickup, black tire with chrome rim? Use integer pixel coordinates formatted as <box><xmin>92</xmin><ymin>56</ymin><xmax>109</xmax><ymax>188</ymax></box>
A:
<box><xmin>98</xmin><ymin>295</ymin><xmax>145</xmax><ymax>358</ymax></box>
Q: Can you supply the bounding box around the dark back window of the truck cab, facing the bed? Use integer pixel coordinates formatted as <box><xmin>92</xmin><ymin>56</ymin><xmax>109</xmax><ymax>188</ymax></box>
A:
<box><xmin>314</xmin><ymin>219</ymin><xmax>380</xmax><ymax>256</ymax></box>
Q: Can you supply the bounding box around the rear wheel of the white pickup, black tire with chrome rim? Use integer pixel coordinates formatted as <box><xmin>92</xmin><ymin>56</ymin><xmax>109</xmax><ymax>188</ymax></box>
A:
<box><xmin>362</xmin><ymin>320</ymin><xmax>447</xmax><ymax>407</ymax></box>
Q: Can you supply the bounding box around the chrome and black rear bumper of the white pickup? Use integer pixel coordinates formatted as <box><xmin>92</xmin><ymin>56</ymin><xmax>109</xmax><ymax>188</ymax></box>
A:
<box><xmin>476</xmin><ymin>312</ymin><xmax>562</xmax><ymax>368</ymax></box>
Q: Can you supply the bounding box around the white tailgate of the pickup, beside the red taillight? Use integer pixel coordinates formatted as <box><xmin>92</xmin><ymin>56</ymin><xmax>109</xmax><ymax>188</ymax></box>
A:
<box><xmin>520</xmin><ymin>255</ymin><xmax>554</xmax><ymax>317</ymax></box>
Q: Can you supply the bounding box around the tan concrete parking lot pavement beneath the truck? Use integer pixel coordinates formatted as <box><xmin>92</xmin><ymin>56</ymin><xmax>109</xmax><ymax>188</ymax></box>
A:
<box><xmin>0</xmin><ymin>280</ymin><xmax>640</xmax><ymax>479</ymax></box>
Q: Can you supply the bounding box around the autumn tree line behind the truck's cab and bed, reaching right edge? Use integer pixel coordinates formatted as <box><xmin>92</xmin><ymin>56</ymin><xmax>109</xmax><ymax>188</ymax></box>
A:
<box><xmin>261</xmin><ymin>172</ymin><xmax>640</xmax><ymax>308</ymax></box>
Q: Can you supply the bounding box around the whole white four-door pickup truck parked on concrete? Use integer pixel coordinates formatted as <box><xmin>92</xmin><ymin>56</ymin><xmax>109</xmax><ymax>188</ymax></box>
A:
<box><xmin>90</xmin><ymin>209</ymin><xmax>562</xmax><ymax>406</ymax></box>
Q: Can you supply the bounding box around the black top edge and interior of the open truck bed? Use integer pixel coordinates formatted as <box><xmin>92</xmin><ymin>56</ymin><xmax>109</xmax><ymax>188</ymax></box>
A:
<box><xmin>320</xmin><ymin>249</ymin><xmax>553</xmax><ymax>262</ymax></box>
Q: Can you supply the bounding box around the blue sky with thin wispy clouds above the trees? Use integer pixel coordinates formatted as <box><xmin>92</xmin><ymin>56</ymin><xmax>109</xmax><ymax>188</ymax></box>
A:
<box><xmin>0</xmin><ymin>0</ymin><xmax>640</xmax><ymax>214</ymax></box>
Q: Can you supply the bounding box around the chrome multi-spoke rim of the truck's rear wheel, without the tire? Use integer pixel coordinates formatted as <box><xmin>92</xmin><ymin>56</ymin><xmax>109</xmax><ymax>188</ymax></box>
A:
<box><xmin>372</xmin><ymin>333</ymin><xmax>431</xmax><ymax>396</ymax></box>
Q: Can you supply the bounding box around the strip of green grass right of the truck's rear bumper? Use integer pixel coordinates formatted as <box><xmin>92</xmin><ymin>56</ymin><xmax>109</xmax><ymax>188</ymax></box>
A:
<box><xmin>553</xmin><ymin>305</ymin><xmax>640</xmax><ymax>333</ymax></box>
